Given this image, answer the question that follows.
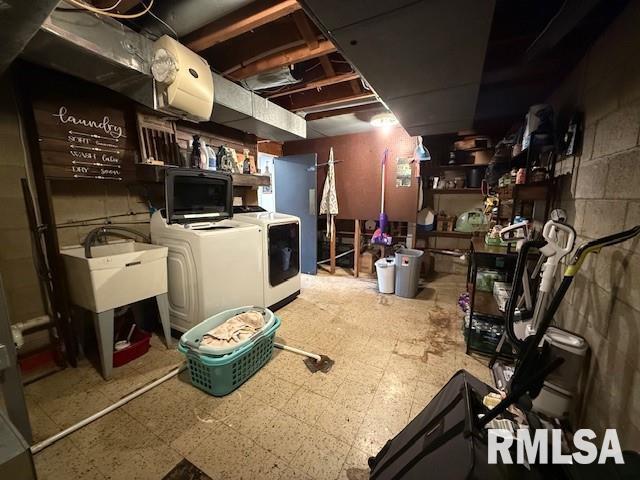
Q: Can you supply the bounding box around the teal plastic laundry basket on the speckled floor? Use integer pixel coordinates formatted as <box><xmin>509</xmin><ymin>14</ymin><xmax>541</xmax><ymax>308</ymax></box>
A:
<box><xmin>178</xmin><ymin>307</ymin><xmax>280</xmax><ymax>397</ymax></box>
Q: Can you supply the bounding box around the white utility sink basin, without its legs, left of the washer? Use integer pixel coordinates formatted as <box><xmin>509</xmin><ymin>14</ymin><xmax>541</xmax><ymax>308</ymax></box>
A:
<box><xmin>60</xmin><ymin>241</ymin><xmax>168</xmax><ymax>313</ymax></box>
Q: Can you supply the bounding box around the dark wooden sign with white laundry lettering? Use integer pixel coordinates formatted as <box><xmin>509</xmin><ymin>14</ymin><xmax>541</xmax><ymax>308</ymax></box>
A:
<box><xmin>31</xmin><ymin>76</ymin><xmax>137</xmax><ymax>182</ymax></box>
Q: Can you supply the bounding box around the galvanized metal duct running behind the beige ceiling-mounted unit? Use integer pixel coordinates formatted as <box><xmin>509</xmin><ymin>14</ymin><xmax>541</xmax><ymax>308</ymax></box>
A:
<box><xmin>22</xmin><ymin>11</ymin><xmax>307</xmax><ymax>142</ymax></box>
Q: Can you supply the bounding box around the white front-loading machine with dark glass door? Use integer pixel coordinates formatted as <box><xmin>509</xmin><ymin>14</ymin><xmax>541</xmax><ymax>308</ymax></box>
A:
<box><xmin>233</xmin><ymin>206</ymin><xmax>300</xmax><ymax>310</ymax></box>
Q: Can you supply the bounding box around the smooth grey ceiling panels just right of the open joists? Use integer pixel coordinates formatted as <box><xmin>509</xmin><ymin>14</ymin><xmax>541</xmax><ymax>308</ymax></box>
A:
<box><xmin>304</xmin><ymin>0</ymin><xmax>494</xmax><ymax>135</ymax></box>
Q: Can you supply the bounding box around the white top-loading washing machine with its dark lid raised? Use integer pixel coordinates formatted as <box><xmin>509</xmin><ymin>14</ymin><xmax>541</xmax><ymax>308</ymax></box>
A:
<box><xmin>151</xmin><ymin>169</ymin><xmax>265</xmax><ymax>332</ymax></box>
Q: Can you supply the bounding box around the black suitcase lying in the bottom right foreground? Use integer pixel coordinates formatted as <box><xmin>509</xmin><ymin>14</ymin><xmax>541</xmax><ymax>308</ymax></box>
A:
<box><xmin>369</xmin><ymin>370</ymin><xmax>549</xmax><ymax>480</ymax></box>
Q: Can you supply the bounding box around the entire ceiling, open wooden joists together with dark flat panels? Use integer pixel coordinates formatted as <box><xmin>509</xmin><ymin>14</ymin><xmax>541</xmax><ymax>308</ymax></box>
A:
<box><xmin>85</xmin><ymin>0</ymin><xmax>627</xmax><ymax>137</ymax></box>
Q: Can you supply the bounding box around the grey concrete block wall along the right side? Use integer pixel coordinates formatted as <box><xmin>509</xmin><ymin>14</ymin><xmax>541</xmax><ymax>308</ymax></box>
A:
<box><xmin>550</xmin><ymin>2</ymin><xmax>640</xmax><ymax>450</ymax></box>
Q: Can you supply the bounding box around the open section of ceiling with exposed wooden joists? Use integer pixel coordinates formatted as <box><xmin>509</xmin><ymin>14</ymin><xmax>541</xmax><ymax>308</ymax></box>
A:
<box><xmin>116</xmin><ymin>0</ymin><xmax>387</xmax><ymax>137</ymax></box>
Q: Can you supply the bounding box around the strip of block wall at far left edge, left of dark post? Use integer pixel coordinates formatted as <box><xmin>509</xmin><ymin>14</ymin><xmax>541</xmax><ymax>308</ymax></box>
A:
<box><xmin>0</xmin><ymin>75</ymin><xmax>46</xmax><ymax>323</ymax></box>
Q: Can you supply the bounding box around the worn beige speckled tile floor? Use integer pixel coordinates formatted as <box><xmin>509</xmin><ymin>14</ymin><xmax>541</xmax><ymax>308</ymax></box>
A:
<box><xmin>26</xmin><ymin>274</ymin><xmax>489</xmax><ymax>480</ymax></box>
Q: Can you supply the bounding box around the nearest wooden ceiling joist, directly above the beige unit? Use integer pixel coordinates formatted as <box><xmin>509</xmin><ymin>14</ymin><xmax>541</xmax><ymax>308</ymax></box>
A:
<box><xmin>182</xmin><ymin>0</ymin><xmax>301</xmax><ymax>52</ymax></box>
